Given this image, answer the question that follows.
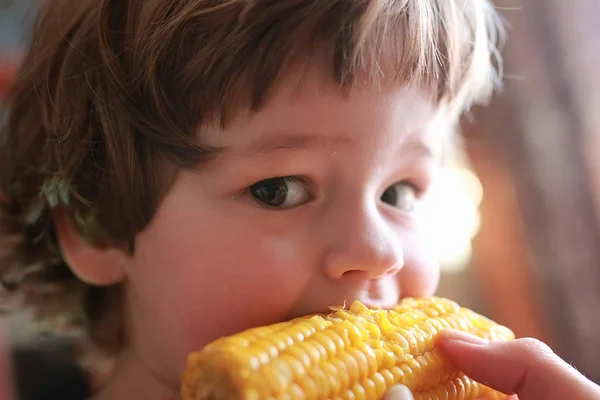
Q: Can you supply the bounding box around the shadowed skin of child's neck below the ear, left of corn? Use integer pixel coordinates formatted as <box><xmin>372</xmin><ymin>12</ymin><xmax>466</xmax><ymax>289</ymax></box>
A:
<box><xmin>93</xmin><ymin>351</ymin><xmax>180</xmax><ymax>400</ymax></box>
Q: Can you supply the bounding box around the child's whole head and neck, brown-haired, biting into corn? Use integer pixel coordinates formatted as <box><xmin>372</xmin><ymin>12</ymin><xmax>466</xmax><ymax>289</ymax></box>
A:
<box><xmin>0</xmin><ymin>0</ymin><xmax>596</xmax><ymax>400</ymax></box>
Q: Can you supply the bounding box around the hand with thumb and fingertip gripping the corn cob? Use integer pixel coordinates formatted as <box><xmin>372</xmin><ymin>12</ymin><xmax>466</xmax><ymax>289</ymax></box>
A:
<box><xmin>384</xmin><ymin>330</ymin><xmax>600</xmax><ymax>400</ymax></box>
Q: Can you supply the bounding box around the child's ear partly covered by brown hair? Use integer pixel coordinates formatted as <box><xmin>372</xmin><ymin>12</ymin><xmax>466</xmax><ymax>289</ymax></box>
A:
<box><xmin>52</xmin><ymin>207</ymin><xmax>127</xmax><ymax>286</ymax></box>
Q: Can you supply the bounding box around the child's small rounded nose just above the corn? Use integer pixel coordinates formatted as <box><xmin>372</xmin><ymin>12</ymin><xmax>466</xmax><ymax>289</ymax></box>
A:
<box><xmin>323</xmin><ymin>202</ymin><xmax>404</xmax><ymax>280</ymax></box>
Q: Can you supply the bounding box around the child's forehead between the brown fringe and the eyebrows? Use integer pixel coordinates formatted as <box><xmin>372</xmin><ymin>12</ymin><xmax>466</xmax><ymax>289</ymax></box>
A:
<box><xmin>199</xmin><ymin>63</ymin><xmax>448</xmax><ymax>152</ymax></box>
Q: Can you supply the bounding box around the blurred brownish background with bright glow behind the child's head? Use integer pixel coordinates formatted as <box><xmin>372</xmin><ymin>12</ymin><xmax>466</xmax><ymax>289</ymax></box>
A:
<box><xmin>0</xmin><ymin>0</ymin><xmax>600</xmax><ymax>383</ymax></box>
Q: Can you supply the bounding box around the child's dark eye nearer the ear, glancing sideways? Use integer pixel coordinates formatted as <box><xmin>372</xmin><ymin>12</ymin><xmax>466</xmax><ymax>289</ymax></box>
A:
<box><xmin>249</xmin><ymin>176</ymin><xmax>310</xmax><ymax>209</ymax></box>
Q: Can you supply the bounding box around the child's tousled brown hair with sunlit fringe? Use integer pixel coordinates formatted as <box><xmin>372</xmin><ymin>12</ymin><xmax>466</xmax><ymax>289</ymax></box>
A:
<box><xmin>0</xmin><ymin>0</ymin><xmax>501</xmax><ymax>349</ymax></box>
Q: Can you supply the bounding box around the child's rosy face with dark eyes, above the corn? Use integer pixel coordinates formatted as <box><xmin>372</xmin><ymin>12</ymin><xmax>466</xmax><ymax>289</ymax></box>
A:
<box><xmin>120</xmin><ymin>69</ymin><xmax>447</xmax><ymax>379</ymax></box>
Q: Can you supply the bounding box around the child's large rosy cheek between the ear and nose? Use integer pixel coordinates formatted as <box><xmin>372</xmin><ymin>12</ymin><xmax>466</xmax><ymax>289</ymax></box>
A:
<box><xmin>130</xmin><ymin>206</ymin><xmax>310</xmax><ymax>352</ymax></box>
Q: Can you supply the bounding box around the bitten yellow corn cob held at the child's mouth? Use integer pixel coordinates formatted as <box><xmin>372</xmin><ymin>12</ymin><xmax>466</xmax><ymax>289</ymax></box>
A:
<box><xmin>181</xmin><ymin>297</ymin><xmax>514</xmax><ymax>400</ymax></box>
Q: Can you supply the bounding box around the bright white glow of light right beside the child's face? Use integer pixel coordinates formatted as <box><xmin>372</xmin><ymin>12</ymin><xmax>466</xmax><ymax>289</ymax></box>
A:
<box><xmin>424</xmin><ymin>167</ymin><xmax>482</xmax><ymax>272</ymax></box>
